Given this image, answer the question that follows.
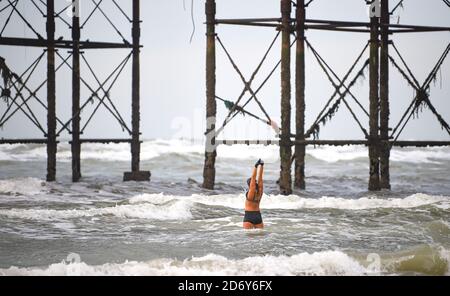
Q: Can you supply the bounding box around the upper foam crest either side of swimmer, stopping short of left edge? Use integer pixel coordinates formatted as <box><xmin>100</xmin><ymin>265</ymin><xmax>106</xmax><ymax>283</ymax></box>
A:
<box><xmin>129</xmin><ymin>193</ymin><xmax>450</xmax><ymax>210</ymax></box>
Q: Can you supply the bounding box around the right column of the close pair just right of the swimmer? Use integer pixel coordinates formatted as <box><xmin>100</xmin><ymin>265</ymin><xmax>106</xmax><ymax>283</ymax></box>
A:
<box><xmin>294</xmin><ymin>0</ymin><xmax>306</xmax><ymax>189</ymax></box>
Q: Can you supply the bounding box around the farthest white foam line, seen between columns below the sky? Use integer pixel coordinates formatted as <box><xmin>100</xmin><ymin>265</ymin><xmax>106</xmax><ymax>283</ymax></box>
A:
<box><xmin>0</xmin><ymin>140</ymin><xmax>450</xmax><ymax>163</ymax></box>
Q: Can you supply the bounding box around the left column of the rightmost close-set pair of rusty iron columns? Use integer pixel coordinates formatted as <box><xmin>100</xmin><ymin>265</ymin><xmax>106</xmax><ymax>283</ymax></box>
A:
<box><xmin>369</xmin><ymin>11</ymin><xmax>380</xmax><ymax>191</ymax></box>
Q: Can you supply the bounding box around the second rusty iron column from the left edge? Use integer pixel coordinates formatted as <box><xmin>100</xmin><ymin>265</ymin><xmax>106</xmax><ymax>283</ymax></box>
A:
<box><xmin>71</xmin><ymin>0</ymin><xmax>81</xmax><ymax>182</ymax></box>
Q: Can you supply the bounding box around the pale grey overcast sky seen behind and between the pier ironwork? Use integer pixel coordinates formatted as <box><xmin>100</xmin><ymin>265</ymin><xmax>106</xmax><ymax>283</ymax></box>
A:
<box><xmin>0</xmin><ymin>0</ymin><xmax>450</xmax><ymax>139</ymax></box>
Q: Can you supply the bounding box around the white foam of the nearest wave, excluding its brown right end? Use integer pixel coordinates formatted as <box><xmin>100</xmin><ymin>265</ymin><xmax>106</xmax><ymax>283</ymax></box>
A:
<box><xmin>0</xmin><ymin>251</ymin><xmax>371</xmax><ymax>276</ymax></box>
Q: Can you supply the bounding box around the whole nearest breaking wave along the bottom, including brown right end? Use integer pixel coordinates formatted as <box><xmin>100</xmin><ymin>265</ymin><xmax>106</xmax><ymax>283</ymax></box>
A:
<box><xmin>0</xmin><ymin>247</ymin><xmax>449</xmax><ymax>276</ymax></box>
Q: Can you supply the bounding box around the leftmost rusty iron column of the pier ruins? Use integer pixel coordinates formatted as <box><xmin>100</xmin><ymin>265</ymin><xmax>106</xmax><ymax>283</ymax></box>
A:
<box><xmin>46</xmin><ymin>0</ymin><xmax>57</xmax><ymax>182</ymax></box>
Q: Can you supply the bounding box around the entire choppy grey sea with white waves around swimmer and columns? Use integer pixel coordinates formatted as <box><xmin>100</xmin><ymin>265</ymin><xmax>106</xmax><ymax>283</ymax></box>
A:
<box><xmin>0</xmin><ymin>140</ymin><xmax>450</xmax><ymax>275</ymax></box>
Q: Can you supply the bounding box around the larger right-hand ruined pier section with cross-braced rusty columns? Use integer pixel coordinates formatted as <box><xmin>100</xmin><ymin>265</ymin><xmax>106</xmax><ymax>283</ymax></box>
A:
<box><xmin>203</xmin><ymin>0</ymin><xmax>450</xmax><ymax>194</ymax></box>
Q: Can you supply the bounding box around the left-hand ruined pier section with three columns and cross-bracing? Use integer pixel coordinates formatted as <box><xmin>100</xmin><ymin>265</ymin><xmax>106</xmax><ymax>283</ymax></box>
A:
<box><xmin>0</xmin><ymin>0</ymin><xmax>150</xmax><ymax>182</ymax></box>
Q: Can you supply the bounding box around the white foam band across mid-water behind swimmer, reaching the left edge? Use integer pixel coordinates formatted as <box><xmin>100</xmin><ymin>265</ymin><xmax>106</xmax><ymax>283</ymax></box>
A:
<box><xmin>0</xmin><ymin>194</ymin><xmax>449</xmax><ymax>220</ymax></box>
